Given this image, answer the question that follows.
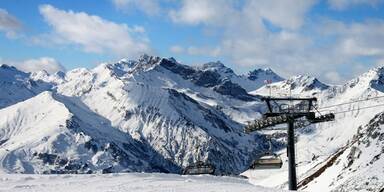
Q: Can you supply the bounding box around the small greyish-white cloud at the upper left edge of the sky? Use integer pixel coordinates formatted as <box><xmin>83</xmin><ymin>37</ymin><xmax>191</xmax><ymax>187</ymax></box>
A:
<box><xmin>0</xmin><ymin>8</ymin><xmax>22</xmax><ymax>38</ymax></box>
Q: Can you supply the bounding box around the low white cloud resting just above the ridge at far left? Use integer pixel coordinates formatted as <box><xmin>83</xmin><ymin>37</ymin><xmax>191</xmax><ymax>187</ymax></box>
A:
<box><xmin>0</xmin><ymin>57</ymin><xmax>65</xmax><ymax>74</ymax></box>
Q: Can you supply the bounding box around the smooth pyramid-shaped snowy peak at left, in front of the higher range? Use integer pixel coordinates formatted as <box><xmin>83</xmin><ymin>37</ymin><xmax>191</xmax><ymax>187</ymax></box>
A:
<box><xmin>0</xmin><ymin>92</ymin><xmax>177</xmax><ymax>173</ymax></box>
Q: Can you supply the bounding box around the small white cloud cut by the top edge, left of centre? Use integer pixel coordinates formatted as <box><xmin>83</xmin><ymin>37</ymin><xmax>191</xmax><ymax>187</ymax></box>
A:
<box><xmin>112</xmin><ymin>0</ymin><xmax>161</xmax><ymax>16</ymax></box>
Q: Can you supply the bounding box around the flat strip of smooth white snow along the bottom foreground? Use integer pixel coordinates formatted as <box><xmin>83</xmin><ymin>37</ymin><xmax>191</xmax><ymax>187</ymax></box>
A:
<box><xmin>0</xmin><ymin>173</ymin><xmax>282</xmax><ymax>192</ymax></box>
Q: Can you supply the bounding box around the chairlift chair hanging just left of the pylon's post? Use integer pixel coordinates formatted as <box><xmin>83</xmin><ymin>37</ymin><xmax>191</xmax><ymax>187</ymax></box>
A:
<box><xmin>250</xmin><ymin>154</ymin><xmax>283</xmax><ymax>169</ymax></box>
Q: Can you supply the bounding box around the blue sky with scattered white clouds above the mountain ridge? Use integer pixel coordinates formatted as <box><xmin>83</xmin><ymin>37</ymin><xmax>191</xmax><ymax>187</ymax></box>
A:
<box><xmin>0</xmin><ymin>0</ymin><xmax>384</xmax><ymax>84</ymax></box>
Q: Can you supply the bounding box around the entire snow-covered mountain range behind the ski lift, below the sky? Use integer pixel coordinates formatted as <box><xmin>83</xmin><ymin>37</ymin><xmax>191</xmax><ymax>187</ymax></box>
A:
<box><xmin>0</xmin><ymin>55</ymin><xmax>384</xmax><ymax>191</ymax></box>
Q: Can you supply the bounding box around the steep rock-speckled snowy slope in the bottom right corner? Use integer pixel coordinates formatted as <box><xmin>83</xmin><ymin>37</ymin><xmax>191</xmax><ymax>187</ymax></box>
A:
<box><xmin>303</xmin><ymin>113</ymin><xmax>384</xmax><ymax>191</ymax></box>
